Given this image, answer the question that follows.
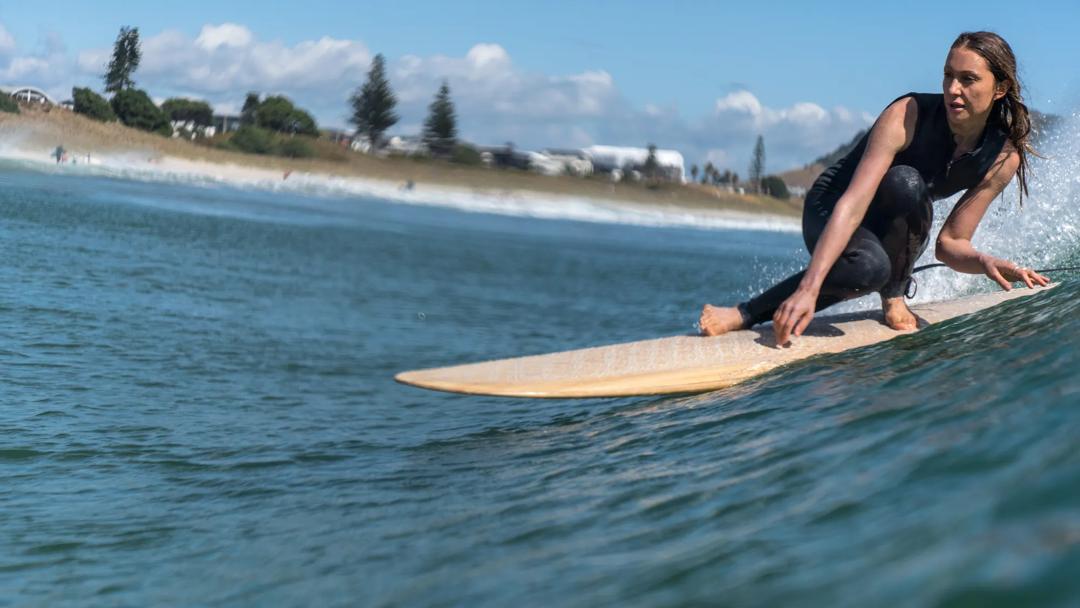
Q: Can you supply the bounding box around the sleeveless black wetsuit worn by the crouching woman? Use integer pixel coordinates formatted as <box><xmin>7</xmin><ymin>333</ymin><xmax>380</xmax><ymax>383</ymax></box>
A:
<box><xmin>739</xmin><ymin>93</ymin><xmax>1008</xmax><ymax>325</ymax></box>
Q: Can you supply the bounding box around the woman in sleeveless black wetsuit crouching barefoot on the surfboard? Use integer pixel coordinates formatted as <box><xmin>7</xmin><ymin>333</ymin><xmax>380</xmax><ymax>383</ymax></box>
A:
<box><xmin>700</xmin><ymin>31</ymin><xmax>1050</xmax><ymax>344</ymax></box>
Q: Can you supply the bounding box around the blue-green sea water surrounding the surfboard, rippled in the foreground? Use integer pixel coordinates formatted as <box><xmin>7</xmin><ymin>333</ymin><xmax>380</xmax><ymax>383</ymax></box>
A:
<box><xmin>0</xmin><ymin>167</ymin><xmax>1080</xmax><ymax>606</ymax></box>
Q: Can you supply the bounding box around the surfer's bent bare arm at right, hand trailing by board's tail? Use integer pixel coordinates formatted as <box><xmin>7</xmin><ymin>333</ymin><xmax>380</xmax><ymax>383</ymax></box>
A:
<box><xmin>934</xmin><ymin>145</ymin><xmax>1050</xmax><ymax>291</ymax></box>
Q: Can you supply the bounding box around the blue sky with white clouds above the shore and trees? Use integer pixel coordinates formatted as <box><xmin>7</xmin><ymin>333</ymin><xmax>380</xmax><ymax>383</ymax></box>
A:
<box><xmin>0</xmin><ymin>0</ymin><xmax>1080</xmax><ymax>174</ymax></box>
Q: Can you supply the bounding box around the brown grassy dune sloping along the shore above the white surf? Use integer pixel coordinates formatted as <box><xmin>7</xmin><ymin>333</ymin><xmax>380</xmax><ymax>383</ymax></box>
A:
<box><xmin>0</xmin><ymin>109</ymin><xmax>801</xmax><ymax>216</ymax></box>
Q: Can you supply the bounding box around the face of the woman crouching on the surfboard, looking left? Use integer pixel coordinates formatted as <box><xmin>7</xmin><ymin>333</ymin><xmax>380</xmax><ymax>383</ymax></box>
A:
<box><xmin>942</xmin><ymin>46</ymin><xmax>1005</xmax><ymax>124</ymax></box>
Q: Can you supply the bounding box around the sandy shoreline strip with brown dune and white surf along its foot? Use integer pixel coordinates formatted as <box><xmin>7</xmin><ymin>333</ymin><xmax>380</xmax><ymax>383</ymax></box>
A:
<box><xmin>0</xmin><ymin>109</ymin><xmax>800</xmax><ymax>232</ymax></box>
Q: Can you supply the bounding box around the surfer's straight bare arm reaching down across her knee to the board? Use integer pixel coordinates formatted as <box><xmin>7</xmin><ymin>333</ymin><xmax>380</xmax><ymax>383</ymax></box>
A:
<box><xmin>772</xmin><ymin>97</ymin><xmax>919</xmax><ymax>344</ymax></box>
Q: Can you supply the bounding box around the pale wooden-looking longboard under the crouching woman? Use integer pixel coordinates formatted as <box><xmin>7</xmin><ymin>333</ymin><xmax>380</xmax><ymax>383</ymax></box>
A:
<box><xmin>394</xmin><ymin>285</ymin><xmax>1054</xmax><ymax>398</ymax></box>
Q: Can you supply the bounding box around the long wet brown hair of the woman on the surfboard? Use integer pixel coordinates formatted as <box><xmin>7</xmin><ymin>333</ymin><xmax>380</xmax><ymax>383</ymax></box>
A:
<box><xmin>949</xmin><ymin>31</ymin><xmax>1038</xmax><ymax>206</ymax></box>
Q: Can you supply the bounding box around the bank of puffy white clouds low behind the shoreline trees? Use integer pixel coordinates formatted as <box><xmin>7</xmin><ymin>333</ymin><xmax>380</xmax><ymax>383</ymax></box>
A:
<box><xmin>0</xmin><ymin>23</ymin><xmax>873</xmax><ymax>173</ymax></box>
